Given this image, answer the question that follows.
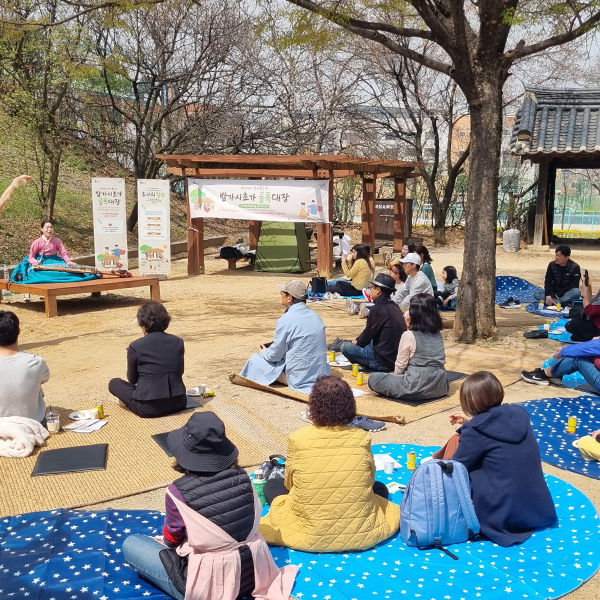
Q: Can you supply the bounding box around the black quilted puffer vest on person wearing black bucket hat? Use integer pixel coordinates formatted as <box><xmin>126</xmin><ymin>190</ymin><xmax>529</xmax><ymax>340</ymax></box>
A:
<box><xmin>160</xmin><ymin>467</ymin><xmax>255</xmax><ymax>598</ymax></box>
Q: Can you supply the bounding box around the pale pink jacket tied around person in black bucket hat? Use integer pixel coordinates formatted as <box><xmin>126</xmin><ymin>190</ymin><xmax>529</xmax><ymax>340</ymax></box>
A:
<box><xmin>167</xmin><ymin>489</ymin><xmax>298</xmax><ymax>600</ymax></box>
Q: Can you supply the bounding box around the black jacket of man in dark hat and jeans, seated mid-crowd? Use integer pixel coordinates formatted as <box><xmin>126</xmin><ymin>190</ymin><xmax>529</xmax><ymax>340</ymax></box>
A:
<box><xmin>356</xmin><ymin>296</ymin><xmax>406</xmax><ymax>371</ymax></box>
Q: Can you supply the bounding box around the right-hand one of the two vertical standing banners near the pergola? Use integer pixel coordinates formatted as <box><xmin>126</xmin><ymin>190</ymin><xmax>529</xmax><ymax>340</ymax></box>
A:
<box><xmin>137</xmin><ymin>179</ymin><xmax>171</xmax><ymax>275</ymax></box>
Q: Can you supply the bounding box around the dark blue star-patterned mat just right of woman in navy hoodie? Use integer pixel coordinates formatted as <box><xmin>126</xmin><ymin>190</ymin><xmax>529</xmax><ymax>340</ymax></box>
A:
<box><xmin>520</xmin><ymin>396</ymin><xmax>600</xmax><ymax>479</ymax></box>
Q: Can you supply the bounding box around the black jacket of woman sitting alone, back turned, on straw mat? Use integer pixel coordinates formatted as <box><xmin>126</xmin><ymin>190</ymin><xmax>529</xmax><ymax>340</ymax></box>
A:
<box><xmin>127</xmin><ymin>331</ymin><xmax>185</xmax><ymax>401</ymax></box>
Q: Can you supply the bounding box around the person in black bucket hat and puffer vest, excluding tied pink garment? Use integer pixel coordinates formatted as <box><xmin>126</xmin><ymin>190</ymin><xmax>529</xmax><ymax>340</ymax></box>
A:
<box><xmin>123</xmin><ymin>412</ymin><xmax>255</xmax><ymax>599</ymax></box>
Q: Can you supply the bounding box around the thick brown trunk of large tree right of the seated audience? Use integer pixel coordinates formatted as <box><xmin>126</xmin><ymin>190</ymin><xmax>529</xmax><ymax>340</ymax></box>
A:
<box><xmin>454</xmin><ymin>91</ymin><xmax>502</xmax><ymax>343</ymax></box>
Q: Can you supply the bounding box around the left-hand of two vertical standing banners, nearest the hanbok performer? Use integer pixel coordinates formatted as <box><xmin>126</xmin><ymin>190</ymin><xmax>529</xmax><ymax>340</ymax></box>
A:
<box><xmin>92</xmin><ymin>177</ymin><xmax>128</xmax><ymax>270</ymax></box>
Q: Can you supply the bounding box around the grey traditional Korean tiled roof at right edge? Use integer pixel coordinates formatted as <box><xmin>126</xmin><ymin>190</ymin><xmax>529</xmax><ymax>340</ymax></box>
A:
<box><xmin>510</xmin><ymin>88</ymin><xmax>600</xmax><ymax>161</ymax></box>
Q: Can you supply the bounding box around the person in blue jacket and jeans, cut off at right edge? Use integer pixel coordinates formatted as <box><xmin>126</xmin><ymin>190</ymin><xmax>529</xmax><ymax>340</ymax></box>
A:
<box><xmin>521</xmin><ymin>338</ymin><xmax>600</xmax><ymax>393</ymax></box>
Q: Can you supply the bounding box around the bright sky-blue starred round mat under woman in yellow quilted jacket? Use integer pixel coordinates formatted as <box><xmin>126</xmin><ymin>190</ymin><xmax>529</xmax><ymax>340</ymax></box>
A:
<box><xmin>271</xmin><ymin>444</ymin><xmax>600</xmax><ymax>600</ymax></box>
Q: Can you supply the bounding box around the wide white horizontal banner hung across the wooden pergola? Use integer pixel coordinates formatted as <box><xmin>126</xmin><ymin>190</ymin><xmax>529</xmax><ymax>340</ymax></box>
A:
<box><xmin>188</xmin><ymin>179</ymin><xmax>330</xmax><ymax>223</ymax></box>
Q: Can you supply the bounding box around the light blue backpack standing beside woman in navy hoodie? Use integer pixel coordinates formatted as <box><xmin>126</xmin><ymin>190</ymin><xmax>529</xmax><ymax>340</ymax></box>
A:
<box><xmin>400</xmin><ymin>459</ymin><xmax>479</xmax><ymax>560</ymax></box>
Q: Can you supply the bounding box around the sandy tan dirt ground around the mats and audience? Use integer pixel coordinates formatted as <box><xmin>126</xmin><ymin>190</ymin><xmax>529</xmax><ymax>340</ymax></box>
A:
<box><xmin>3</xmin><ymin>241</ymin><xmax>600</xmax><ymax>600</ymax></box>
